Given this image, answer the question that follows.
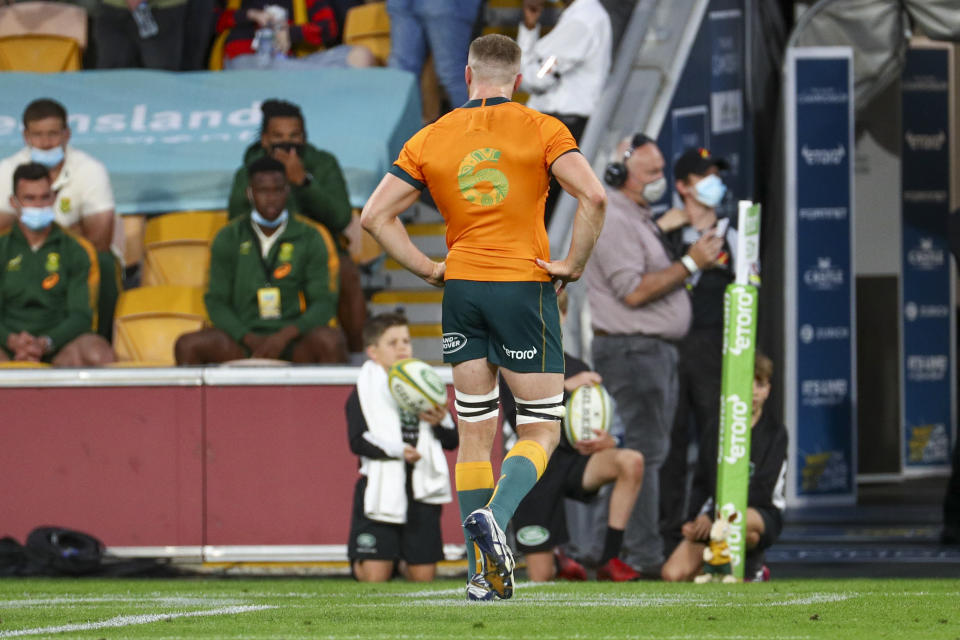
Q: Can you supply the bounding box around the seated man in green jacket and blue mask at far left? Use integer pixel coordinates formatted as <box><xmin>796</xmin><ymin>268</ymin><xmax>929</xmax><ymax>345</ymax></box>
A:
<box><xmin>0</xmin><ymin>162</ymin><xmax>116</xmax><ymax>367</ymax></box>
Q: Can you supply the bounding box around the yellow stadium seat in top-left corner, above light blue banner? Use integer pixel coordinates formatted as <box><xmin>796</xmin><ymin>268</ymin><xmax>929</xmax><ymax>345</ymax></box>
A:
<box><xmin>0</xmin><ymin>2</ymin><xmax>87</xmax><ymax>73</ymax></box>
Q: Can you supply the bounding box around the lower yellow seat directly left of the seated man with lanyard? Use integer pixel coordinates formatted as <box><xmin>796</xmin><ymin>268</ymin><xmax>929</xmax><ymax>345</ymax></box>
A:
<box><xmin>113</xmin><ymin>285</ymin><xmax>207</xmax><ymax>366</ymax></box>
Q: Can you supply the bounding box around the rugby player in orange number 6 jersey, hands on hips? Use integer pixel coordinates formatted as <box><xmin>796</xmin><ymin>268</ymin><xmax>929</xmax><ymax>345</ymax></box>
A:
<box><xmin>361</xmin><ymin>35</ymin><xmax>606</xmax><ymax>600</ymax></box>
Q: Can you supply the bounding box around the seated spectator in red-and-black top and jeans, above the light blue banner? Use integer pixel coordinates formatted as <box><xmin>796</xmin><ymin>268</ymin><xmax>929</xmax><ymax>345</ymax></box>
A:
<box><xmin>217</xmin><ymin>0</ymin><xmax>376</xmax><ymax>70</ymax></box>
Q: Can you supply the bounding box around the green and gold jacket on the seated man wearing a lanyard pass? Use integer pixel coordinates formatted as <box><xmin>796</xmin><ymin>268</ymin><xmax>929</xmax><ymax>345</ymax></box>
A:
<box><xmin>204</xmin><ymin>214</ymin><xmax>340</xmax><ymax>342</ymax></box>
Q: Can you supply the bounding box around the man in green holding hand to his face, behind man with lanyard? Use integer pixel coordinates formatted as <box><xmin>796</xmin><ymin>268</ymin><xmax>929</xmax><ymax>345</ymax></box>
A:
<box><xmin>229</xmin><ymin>100</ymin><xmax>367</xmax><ymax>353</ymax></box>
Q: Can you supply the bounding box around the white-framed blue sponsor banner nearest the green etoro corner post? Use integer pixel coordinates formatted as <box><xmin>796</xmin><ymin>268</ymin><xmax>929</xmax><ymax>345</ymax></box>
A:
<box><xmin>783</xmin><ymin>47</ymin><xmax>856</xmax><ymax>505</ymax></box>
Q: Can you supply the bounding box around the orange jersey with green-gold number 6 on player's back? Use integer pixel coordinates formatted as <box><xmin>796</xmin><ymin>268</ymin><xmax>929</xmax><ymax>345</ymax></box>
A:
<box><xmin>390</xmin><ymin>98</ymin><xmax>577</xmax><ymax>282</ymax></box>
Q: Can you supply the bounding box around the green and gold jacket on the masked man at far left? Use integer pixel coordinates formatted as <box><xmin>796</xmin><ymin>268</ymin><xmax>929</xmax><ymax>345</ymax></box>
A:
<box><xmin>0</xmin><ymin>223</ymin><xmax>100</xmax><ymax>351</ymax></box>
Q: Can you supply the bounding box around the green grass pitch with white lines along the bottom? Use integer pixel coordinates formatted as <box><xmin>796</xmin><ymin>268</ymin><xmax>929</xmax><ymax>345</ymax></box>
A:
<box><xmin>0</xmin><ymin>578</ymin><xmax>960</xmax><ymax>640</ymax></box>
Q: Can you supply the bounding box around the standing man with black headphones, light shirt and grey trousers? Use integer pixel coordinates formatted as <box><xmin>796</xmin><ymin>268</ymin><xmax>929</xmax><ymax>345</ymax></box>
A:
<box><xmin>584</xmin><ymin>133</ymin><xmax>723</xmax><ymax>578</ymax></box>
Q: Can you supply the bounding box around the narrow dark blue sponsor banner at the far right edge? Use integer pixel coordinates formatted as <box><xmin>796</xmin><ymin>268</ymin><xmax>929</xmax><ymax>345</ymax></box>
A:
<box><xmin>900</xmin><ymin>48</ymin><xmax>955</xmax><ymax>474</ymax></box>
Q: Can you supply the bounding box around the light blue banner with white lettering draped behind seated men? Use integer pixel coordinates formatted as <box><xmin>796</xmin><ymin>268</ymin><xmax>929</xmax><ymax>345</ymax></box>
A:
<box><xmin>0</xmin><ymin>69</ymin><xmax>422</xmax><ymax>213</ymax></box>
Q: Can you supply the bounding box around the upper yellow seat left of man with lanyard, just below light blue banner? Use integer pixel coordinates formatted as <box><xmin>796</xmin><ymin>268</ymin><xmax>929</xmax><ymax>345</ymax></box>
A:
<box><xmin>141</xmin><ymin>211</ymin><xmax>227</xmax><ymax>287</ymax></box>
